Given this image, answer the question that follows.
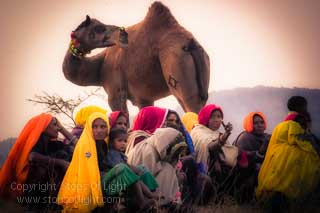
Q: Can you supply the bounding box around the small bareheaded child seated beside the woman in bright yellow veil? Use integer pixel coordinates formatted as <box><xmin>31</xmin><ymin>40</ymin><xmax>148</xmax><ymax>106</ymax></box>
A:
<box><xmin>102</xmin><ymin>129</ymin><xmax>158</xmax><ymax>210</ymax></box>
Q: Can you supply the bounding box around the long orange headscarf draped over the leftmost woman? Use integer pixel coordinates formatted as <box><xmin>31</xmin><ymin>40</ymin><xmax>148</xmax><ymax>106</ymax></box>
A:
<box><xmin>0</xmin><ymin>113</ymin><xmax>52</xmax><ymax>198</ymax></box>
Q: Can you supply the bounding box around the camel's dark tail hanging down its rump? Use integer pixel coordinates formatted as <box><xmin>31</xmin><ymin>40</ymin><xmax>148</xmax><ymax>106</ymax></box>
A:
<box><xmin>188</xmin><ymin>39</ymin><xmax>210</xmax><ymax>101</ymax></box>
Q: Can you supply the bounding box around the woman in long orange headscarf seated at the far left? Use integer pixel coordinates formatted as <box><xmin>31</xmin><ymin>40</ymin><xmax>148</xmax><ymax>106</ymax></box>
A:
<box><xmin>0</xmin><ymin>113</ymin><xmax>72</xmax><ymax>203</ymax></box>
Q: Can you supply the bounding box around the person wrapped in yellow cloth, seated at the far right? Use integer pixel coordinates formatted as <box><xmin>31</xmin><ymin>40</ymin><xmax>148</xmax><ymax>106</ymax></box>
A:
<box><xmin>256</xmin><ymin>114</ymin><xmax>320</xmax><ymax>208</ymax></box>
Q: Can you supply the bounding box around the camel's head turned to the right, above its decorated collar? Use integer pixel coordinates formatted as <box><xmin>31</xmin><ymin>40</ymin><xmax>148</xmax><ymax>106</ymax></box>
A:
<box><xmin>72</xmin><ymin>15</ymin><xmax>121</xmax><ymax>51</ymax></box>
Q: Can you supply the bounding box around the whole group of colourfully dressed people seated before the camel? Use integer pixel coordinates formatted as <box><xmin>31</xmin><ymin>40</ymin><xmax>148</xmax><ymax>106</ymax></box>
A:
<box><xmin>0</xmin><ymin>96</ymin><xmax>320</xmax><ymax>212</ymax></box>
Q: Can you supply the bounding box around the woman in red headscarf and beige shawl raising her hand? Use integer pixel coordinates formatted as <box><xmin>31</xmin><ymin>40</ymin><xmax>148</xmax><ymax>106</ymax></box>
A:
<box><xmin>190</xmin><ymin>104</ymin><xmax>251</xmax><ymax>202</ymax></box>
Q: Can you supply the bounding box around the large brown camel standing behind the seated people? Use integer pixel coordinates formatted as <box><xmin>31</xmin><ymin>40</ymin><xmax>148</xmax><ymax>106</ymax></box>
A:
<box><xmin>63</xmin><ymin>2</ymin><xmax>210</xmax><ymax>113</ymax></box>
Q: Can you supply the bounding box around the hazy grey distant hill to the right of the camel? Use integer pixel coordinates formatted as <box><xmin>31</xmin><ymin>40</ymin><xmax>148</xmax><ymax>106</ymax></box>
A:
<box><xmin>177</xmin><ymin>86</ymin><xmax>320</xmax><ymax>141</ymax></box>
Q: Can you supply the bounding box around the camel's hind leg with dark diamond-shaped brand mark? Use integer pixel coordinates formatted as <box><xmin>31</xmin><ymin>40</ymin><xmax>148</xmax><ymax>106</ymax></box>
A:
<box><xmin>159</xmin><ymin>42</ymin><xmax>206</xmax><ymax>113</ymax></box>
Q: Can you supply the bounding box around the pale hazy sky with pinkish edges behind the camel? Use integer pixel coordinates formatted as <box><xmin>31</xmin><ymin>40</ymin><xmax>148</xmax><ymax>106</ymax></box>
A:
<box><xmin>0</xmin><ymin>0</ymin><xmax>320</xmax><ymax>139</ymax></box>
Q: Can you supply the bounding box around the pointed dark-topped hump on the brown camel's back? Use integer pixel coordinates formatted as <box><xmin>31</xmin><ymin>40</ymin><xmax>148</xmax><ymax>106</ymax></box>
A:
<box><xmin>145</xmin><ymin>1</ymin><xmax>177</xmax><ymax>26</ymax></box>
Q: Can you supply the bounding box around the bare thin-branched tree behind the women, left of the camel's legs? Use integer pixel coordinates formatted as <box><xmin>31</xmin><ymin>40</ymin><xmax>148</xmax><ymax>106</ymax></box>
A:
<box><xmin>27</xmin><ymin>87</ymin><xmax>106</xmax><ymax>126</ymax></box>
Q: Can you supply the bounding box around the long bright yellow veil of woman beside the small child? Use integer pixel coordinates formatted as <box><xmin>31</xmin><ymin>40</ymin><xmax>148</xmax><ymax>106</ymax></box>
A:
<box><xmin>57</xmin><ymin>112</ymin><xmax>110</xmax><ymax>212</ymax></box>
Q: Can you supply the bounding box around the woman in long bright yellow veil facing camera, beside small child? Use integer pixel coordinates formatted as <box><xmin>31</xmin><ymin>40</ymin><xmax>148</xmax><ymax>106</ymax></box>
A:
<box><xmin>57</xmin><ymin>112</ymin><xmax>158</xmax><ymax>212</ymax></box>
